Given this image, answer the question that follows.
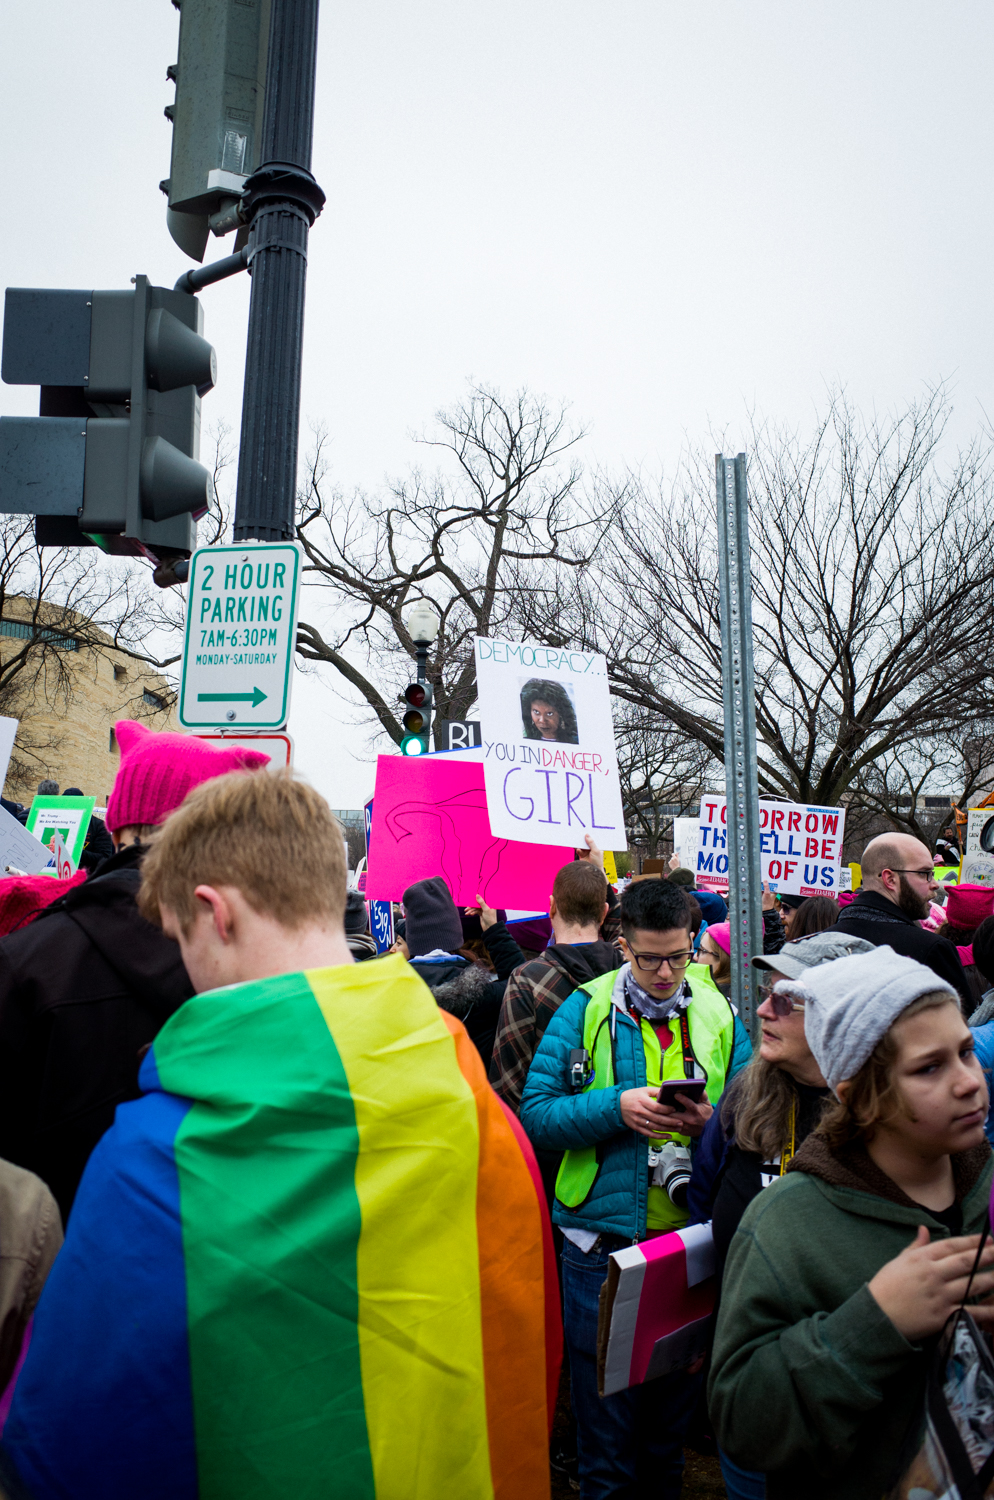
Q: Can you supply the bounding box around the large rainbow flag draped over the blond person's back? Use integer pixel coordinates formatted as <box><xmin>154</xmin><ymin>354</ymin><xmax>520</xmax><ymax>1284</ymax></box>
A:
<box><xmin>4</xmin><ymin>956</ymin><xmax>559</xmax><ymax>1500</ymax></box>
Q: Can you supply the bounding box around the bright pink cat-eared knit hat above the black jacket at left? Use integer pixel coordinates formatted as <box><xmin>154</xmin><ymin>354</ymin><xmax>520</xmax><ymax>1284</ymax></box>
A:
<box><xmin>106</xmin><ymin>719</ymin><xmax>270</xmax><ymax>834</ymax></box>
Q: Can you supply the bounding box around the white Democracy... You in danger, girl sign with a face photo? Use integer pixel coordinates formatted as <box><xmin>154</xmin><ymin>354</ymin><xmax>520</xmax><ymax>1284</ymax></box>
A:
<box><xmin>474</xmin><ymin>636</ymin><xmax>628</xmax><ymax>851</ymax></box>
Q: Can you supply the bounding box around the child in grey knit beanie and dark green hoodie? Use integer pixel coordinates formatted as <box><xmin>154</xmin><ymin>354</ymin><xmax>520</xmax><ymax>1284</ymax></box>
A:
<box><xmin>708</xmin><ymin>945</ymin><xmax>994</xmax><ymax>1500</ymax></box>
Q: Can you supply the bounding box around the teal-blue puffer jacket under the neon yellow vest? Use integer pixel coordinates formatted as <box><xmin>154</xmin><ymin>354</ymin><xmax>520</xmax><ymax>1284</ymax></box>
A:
<box><xmin>520</xmin><ymin>990</ymin><xmax>753</xmax><ymax>1241</ymax></box>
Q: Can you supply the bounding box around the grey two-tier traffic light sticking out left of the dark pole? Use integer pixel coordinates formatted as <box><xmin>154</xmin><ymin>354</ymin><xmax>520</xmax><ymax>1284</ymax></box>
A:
<box><xmin>0</xmin><ymin>276</ymin><xmax>216</xmax><ymax>567</ymax></box>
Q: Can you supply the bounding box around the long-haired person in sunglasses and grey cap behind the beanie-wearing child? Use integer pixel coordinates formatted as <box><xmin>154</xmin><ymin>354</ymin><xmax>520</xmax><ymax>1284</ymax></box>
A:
<box><xmin>687</xmin><ymin>933</ymin><xmax>873</xmax><ymax>1500</ymax></box>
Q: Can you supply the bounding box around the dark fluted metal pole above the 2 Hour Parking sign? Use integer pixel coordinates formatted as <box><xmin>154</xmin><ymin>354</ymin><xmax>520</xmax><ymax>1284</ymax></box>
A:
<box><xmin>234</xmin><ymin>0</ymin><xmax>324</xmax><ymax>542</ymax></box>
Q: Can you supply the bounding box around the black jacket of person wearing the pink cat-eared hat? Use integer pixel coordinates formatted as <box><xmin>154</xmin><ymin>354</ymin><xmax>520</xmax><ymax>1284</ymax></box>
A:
<box><xmin>0</xmin><ymin>848</ymin><xmax>193</xmax><ymax>1223</ymax></box>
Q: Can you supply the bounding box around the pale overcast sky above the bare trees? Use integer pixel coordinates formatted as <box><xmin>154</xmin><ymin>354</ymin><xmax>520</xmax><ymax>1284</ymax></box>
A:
<box><xmin>0</xmin><ymin>0</ymin><xmax>994</xmax><ymax>807</ymax></box>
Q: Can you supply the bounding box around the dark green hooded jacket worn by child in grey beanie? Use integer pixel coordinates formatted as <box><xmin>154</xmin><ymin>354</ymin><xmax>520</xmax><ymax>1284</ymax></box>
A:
<box><xmin>708</xmin><ymin>1134</ymin><xmax>993</xmax><ymax>1500</ymax></box>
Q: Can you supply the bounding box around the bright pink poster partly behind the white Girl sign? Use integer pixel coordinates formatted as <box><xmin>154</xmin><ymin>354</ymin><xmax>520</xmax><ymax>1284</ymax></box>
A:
<box><xmin>364</xmin><ymin>755</ymin><xmax>573</xmax><ymax>912</ymax></box>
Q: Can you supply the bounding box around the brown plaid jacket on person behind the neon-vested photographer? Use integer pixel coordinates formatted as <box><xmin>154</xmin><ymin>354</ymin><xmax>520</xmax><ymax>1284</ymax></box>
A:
<box><xmin>490</xmin><ymin>942</ymin><xmax>624</xmax><ymax>1115</ymax></box>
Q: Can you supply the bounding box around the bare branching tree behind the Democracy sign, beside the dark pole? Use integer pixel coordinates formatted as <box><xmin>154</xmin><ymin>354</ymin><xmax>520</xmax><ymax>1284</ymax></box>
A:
<box><xmin>297</xmin><ymin>386</ymin><xmax>615</xmax><ymax>743</ymax></box>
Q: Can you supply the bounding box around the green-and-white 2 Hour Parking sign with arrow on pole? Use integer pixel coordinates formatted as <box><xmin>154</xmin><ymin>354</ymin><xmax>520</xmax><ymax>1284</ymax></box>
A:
<box><xmin>180</xmin><ymin>542</ymin><xmax>301</xmax><ymax>732</ymax></box>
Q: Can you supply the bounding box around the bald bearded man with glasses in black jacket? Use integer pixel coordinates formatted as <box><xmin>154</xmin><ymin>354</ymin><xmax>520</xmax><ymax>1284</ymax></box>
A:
<box><xmin>835</xmin><ymin>834</ymin><xmax>973</xmax><ymax>1011</ymax></box>
